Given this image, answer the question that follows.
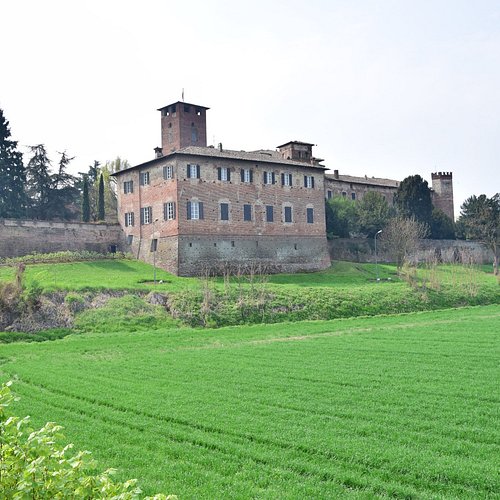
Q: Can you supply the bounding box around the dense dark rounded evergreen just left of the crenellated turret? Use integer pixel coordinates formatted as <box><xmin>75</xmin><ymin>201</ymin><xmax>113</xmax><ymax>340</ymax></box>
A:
<box><xmin>394</xmin><ymin>175</ymin><xmax>432</xmax><ymax>227</ymax></box>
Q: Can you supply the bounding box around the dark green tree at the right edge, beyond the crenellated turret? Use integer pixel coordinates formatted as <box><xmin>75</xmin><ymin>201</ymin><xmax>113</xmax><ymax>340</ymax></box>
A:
<box><xmin>459</xmin><ymin>193</ymin><xmax>500</xmax><ymax>276</ymax></box>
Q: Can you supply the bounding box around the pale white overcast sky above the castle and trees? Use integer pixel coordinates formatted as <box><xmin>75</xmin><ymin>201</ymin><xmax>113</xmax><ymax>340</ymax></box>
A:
<box><xmin>0</xmin><ymin>0</ymin><xmax>500</xmax><ymax>215</ymax></box>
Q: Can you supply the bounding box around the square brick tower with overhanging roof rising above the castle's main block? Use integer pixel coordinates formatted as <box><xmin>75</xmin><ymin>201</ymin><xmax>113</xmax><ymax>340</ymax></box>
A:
<box><xmin>158</xmin><ymin>101</ymin><xmax>209</xmax><ymax>155</ymax></box>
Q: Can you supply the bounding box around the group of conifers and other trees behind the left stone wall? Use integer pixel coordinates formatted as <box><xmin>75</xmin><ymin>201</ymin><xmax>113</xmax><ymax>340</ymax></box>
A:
<box><xmin>0</xmin><ymin>109</ymin><xmax>129</xmax><ymax>222</ymax></box>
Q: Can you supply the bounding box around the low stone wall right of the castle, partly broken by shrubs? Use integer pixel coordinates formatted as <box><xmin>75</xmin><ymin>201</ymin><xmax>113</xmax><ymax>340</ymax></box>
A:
<box><xmin>328</xmin><ymin>238</ymin><xmax>493</xmax><ymax>264</ymax></box>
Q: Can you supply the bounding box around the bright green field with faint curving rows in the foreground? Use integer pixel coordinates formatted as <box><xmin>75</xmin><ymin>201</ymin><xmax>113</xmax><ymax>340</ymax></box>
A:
<box><xmin>0</xmin><ymin>306</ymin><xmax>500</xmax><ymax>498</ymax></box>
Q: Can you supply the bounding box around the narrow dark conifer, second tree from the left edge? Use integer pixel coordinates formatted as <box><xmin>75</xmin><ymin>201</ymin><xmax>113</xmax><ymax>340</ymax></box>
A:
<box><xmin>26</xmin><ymin>144</ymin><xmax>52</xmax><ymax>220</ymax></box>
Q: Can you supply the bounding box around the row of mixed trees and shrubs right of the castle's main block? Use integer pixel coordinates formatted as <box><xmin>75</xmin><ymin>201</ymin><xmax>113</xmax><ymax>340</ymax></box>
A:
<box><xmin>326</xmin><ymin>175</ymin><xmax>500</xmax><ymax>274</ymax></box>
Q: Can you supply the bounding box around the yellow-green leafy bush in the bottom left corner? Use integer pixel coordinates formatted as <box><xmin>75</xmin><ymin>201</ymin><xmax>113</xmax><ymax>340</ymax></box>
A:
<box><xmin>0</xmin><ymin>382</ymin><xmax>175</xmax><ymax>500</ymax></box>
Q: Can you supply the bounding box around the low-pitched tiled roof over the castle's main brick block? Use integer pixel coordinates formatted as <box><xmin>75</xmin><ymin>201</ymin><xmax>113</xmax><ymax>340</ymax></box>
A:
<box><xmin>112</xmin><ymin>146</ymin><xmax>326</xmax><ymax>175</ymax></box>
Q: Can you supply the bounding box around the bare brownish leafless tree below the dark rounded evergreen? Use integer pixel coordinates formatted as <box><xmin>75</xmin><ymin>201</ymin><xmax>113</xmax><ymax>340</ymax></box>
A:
<box><xmin>380</xmin><ymin>215</ymin><xmax>428</xmax><ymax>269</ymax></box>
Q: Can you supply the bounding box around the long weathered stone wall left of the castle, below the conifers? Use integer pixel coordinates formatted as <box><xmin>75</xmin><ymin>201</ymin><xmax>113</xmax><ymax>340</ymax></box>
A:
<box><xmin>0</xmin><ymin>219</ymin><xmax>125</xmax><ymax>258</ymax></box>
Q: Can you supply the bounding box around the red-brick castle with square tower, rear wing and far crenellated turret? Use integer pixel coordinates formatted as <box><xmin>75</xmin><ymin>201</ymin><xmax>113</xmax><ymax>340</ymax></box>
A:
<box><xmin>113</xmin><ymin>101</ymin><xmax>453</xmax><ymax>276</ymax></box>
